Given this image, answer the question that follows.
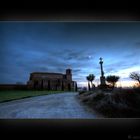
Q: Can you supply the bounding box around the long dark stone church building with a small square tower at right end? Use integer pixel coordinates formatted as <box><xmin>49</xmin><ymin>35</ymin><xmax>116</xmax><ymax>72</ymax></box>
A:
<box><xmin>27</xmin><ymin>69</ymin><xmax>77</xmax><ymax>91</ymax></box>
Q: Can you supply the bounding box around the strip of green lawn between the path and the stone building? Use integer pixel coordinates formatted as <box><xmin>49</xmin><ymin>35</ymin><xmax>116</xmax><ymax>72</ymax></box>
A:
<box><xmin>0</xmin><ymin>90</ymin><xmax>64</xmax><ymax>102</ymax></box>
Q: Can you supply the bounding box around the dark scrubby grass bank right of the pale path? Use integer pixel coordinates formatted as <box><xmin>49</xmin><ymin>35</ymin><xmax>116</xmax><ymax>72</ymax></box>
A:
<box><xmin>79</xmin><ymin>88</ymin><xmax>140</xmax><ymax>118</ymax></box>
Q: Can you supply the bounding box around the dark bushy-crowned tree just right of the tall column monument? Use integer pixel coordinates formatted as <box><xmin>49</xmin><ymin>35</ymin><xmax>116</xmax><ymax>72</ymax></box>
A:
<box><xmin>106</xmin><ymin>75</ymin><xmax>120</xmax><ymax>89</ymax></box>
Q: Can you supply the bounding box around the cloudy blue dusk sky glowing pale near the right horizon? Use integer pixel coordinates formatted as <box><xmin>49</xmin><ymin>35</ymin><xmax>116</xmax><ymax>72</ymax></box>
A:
<box><xmin>0</xmin><ymin>22</ymin><xmax>140</xmax><ymax>86</ymax></box>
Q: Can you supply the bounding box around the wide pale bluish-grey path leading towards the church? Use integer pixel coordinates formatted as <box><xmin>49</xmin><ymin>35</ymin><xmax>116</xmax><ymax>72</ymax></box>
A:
<box><xmin>0</xmin><ymin>92</ymin><xmax>101</xmax><ymax>119</ymax></box>
